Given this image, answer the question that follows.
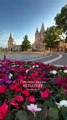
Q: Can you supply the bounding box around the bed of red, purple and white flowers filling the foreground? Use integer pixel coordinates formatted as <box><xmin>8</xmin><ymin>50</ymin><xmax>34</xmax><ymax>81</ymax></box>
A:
<box><xmin>0</xmin><ymin>59</ymin><xmax>67</xmax><ymax>120</ymax></box>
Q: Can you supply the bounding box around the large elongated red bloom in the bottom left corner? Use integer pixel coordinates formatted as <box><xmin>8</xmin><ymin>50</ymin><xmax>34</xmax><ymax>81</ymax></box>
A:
<box><xmin>0</xmin><ymin>102</ymin><xmax>8</xmax><ymax>120</ymax></box>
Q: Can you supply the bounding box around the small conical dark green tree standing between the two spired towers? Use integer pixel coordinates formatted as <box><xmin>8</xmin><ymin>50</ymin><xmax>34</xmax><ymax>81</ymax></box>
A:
<box><xmin>21</xmin><ymin>35</ymin><xmax>31</xmax><ymax>51</ymax></box>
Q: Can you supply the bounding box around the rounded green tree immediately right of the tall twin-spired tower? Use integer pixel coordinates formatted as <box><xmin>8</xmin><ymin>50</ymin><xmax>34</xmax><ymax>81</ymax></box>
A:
<box><xmin>43</xmin><ymin>26</ymin><xmax>62</xmax><ymax>50</ymax></box>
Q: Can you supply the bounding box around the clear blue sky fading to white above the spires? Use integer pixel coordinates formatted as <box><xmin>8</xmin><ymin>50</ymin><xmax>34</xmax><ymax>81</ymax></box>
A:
<box><xmin>0</xmin><ymin>0</ymin><xmax>67</xmax><ymax>47</ymax></box>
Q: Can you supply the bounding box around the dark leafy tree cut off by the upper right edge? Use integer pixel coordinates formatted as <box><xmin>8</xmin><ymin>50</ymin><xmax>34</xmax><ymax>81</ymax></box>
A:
<box><xmin>55</xmin><ymin>4</ymin><xmax>67</xmax><ymax>32</ymax></box>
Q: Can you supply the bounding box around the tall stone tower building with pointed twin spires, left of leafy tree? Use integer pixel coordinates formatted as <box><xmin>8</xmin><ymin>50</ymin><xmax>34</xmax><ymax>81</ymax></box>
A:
<box><xmin>32</xmin><ymin>23</ymin><xmax>45</xmax><ymax>52</ymax></box>
